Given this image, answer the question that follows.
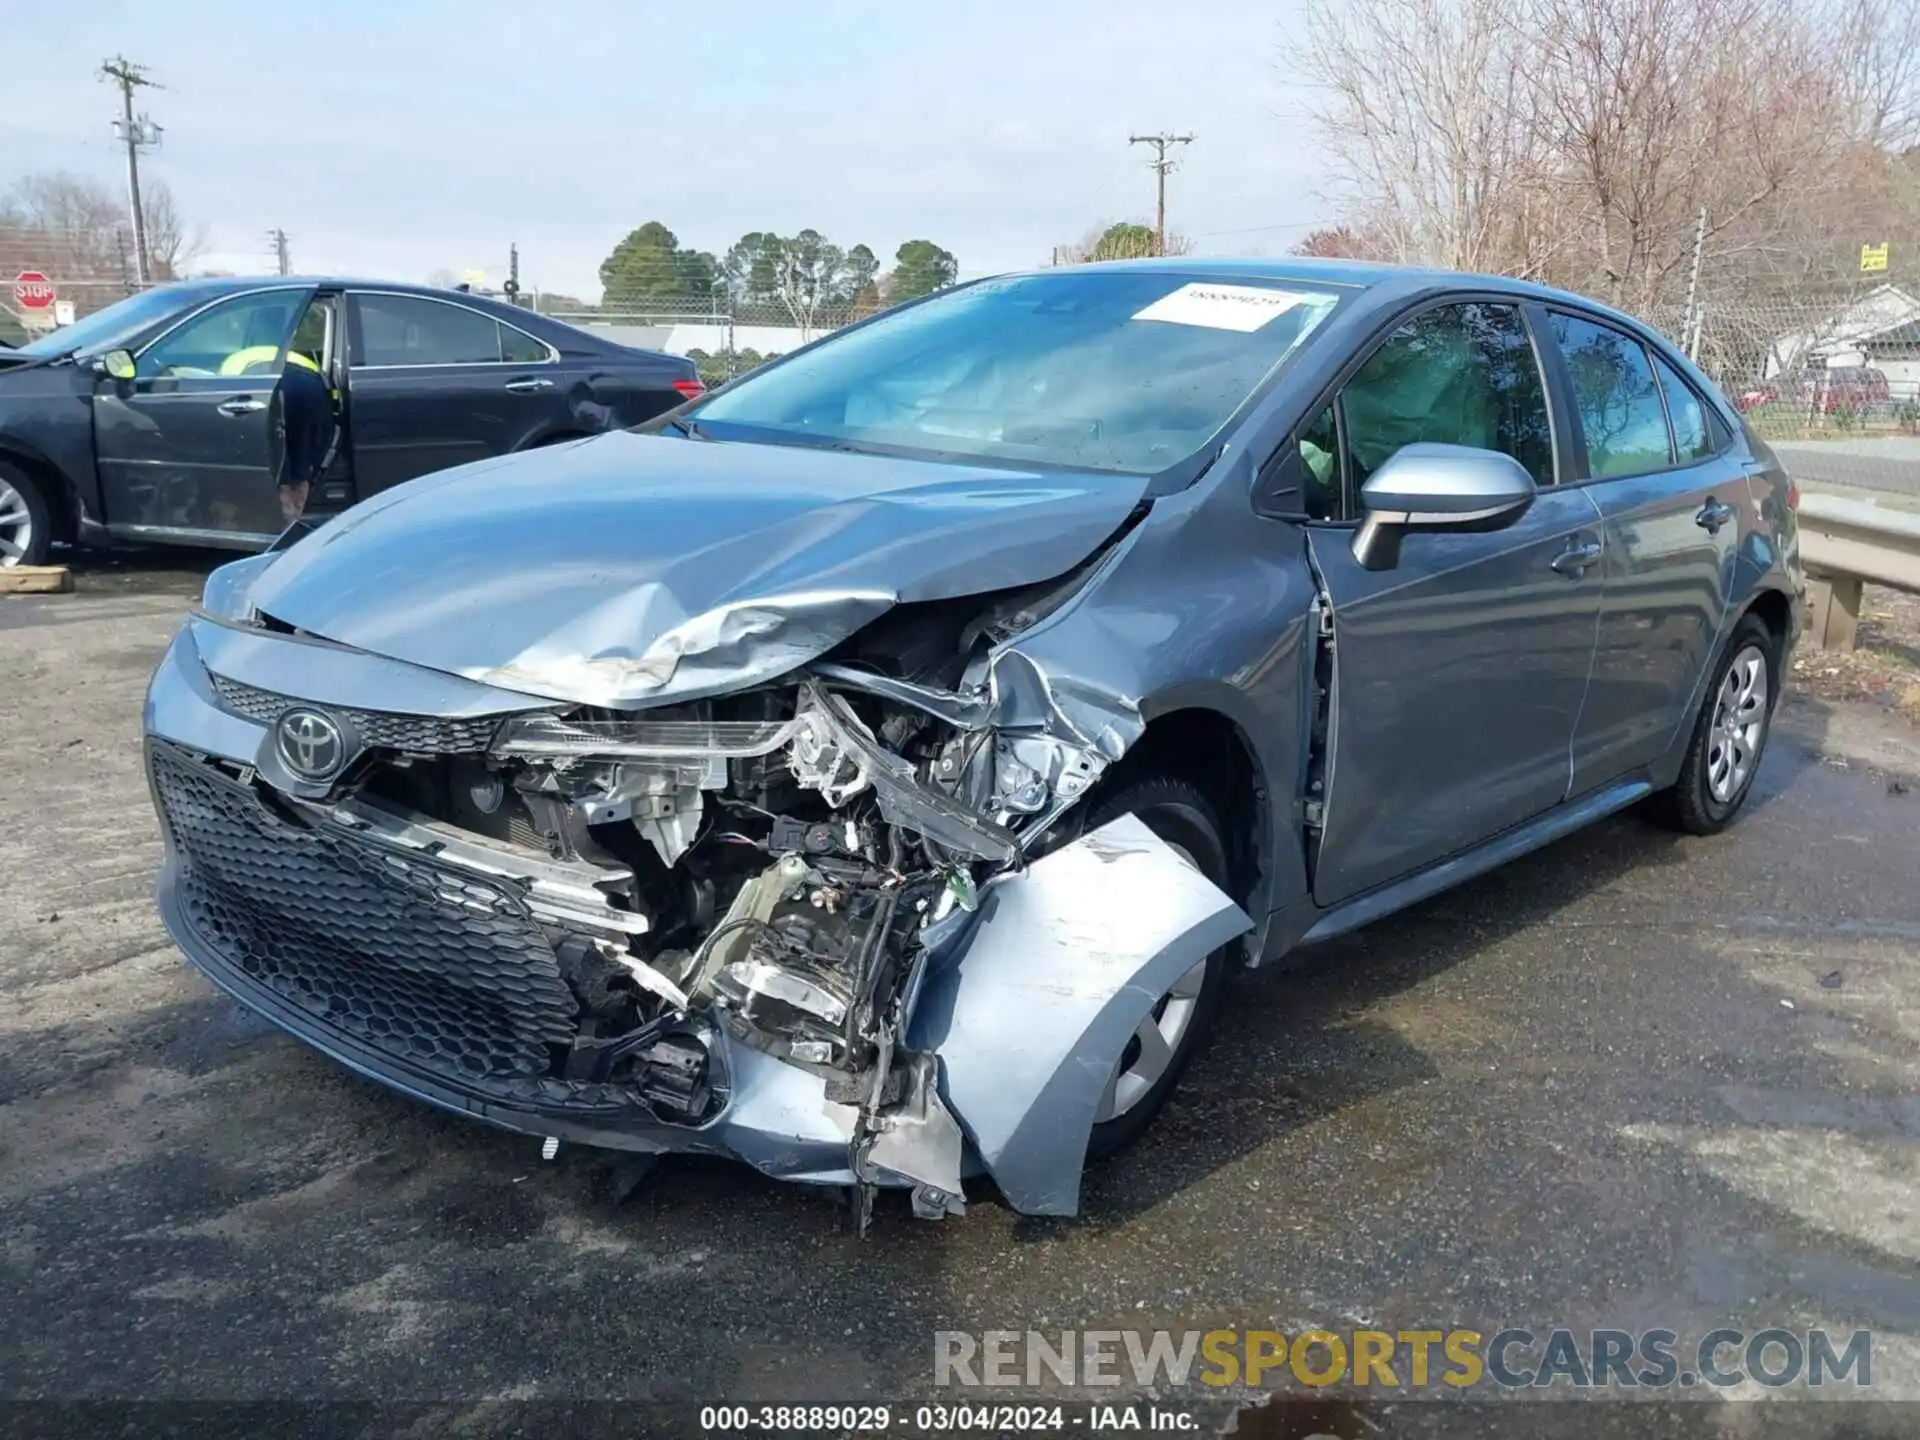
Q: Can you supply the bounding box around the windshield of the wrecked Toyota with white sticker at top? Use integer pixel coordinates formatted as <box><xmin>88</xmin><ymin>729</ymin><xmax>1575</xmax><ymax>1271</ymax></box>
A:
<box><xmin>689</xmin><ymin>271</ymin><xmax>1338</xmax><ymax>474</ymax></box>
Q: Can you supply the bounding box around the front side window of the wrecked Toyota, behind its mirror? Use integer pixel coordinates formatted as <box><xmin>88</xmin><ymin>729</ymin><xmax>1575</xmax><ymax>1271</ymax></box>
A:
<box><xmin>1328</xmin><ymin>301</ymin><xmax>1553</xmax><ymax>493</ymax></box>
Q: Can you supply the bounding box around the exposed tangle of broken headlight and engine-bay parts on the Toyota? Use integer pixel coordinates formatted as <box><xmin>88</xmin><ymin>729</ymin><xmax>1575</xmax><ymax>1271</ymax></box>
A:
<box><xmin>288</xmin><ymin>583</ymin><xmax>1117</xmax><ymax>1215</ymax></box>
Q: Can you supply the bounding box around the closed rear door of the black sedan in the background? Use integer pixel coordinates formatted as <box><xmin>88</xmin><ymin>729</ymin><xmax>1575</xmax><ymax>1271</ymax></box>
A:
<box><xmin>348</xmin><ymin>290</ymin><xmax>566</xmax><ymax>497</ymax></box>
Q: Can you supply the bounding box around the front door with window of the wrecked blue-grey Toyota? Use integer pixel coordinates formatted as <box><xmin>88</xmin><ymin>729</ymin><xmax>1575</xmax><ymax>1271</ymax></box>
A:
<box><xmin>1300</xmin><ymin>301</ymin><xmax>1601</xmax><ymax>906</ymax></box>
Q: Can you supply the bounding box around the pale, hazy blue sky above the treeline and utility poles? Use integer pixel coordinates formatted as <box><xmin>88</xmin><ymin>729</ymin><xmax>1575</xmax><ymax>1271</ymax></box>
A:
<box><xmin>11</xmin><ymin>0</ymin><xmax>1327</xmax><ymax>296</ymax></box>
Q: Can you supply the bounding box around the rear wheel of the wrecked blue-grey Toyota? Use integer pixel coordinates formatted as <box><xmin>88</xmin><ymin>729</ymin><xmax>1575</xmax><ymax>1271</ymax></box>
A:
<box><xmin>1653</xmin><ymin>614</ymin><xmax>1780</xmax><ymax>835</ymax></box>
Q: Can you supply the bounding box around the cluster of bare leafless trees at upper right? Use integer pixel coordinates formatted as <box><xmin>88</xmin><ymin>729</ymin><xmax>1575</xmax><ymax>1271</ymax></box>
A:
<box><xmin>1304</xmin><ymin>0</ymin><xmax>1920</xmax><ymax>311</ymax></box>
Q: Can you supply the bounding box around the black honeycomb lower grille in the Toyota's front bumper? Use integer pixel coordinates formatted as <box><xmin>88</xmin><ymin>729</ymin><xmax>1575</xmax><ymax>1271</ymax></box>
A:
<box><xmin>150</xmin><ymin>739</ymin><xmax>588</xmax><ymax>1098</ymax></box>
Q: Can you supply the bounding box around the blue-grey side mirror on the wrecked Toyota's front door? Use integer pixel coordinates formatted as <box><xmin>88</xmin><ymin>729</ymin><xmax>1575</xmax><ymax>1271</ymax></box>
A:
<box><xmin>1354</xmin><ymin>442</ymin><xmax>1538</xmax><ymax>570</ymax></box>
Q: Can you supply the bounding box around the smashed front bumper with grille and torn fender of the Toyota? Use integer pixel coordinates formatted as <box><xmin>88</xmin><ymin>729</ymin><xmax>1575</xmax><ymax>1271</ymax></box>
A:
<box><xmin>146</xmin><ymin>616</ymin><xmax>1250</xmax><ymax>1215</ymax></box>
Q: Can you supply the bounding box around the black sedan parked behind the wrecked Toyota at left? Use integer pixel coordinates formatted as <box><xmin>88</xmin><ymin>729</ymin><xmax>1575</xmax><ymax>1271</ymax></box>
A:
<box><xmin>0</xmin><ymin>276</ymin><xmax>701</xmax><ymax>566</ymax></box>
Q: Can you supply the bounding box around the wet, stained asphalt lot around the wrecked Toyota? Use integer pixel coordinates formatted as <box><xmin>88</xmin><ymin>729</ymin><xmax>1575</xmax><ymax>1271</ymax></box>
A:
<box><xmin>0</xmin><ymin>557</ymin><xmax>1920</xmax><ymax>1428</ymax></box>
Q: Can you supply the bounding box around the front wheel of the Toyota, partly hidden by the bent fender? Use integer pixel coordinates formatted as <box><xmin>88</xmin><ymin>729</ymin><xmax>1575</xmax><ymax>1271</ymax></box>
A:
<box><xmin>1085</xmin><ymin>776</ymin><xmax>1233</xmax><ymax>1162</ymax></box>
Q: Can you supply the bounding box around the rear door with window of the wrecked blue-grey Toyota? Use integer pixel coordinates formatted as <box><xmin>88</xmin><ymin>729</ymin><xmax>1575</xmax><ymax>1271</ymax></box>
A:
<box><xmin>1548</xmin><ymin>311</ymin><xmax>1753</xmax><ymax>795</ymax></box>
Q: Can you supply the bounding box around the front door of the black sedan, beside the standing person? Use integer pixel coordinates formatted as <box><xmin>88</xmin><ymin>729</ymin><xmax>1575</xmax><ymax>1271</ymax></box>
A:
<box><xmin>94</xmin><ymin>288</ymin><xmax>313</xmax><ymax>547</ymax></box>
